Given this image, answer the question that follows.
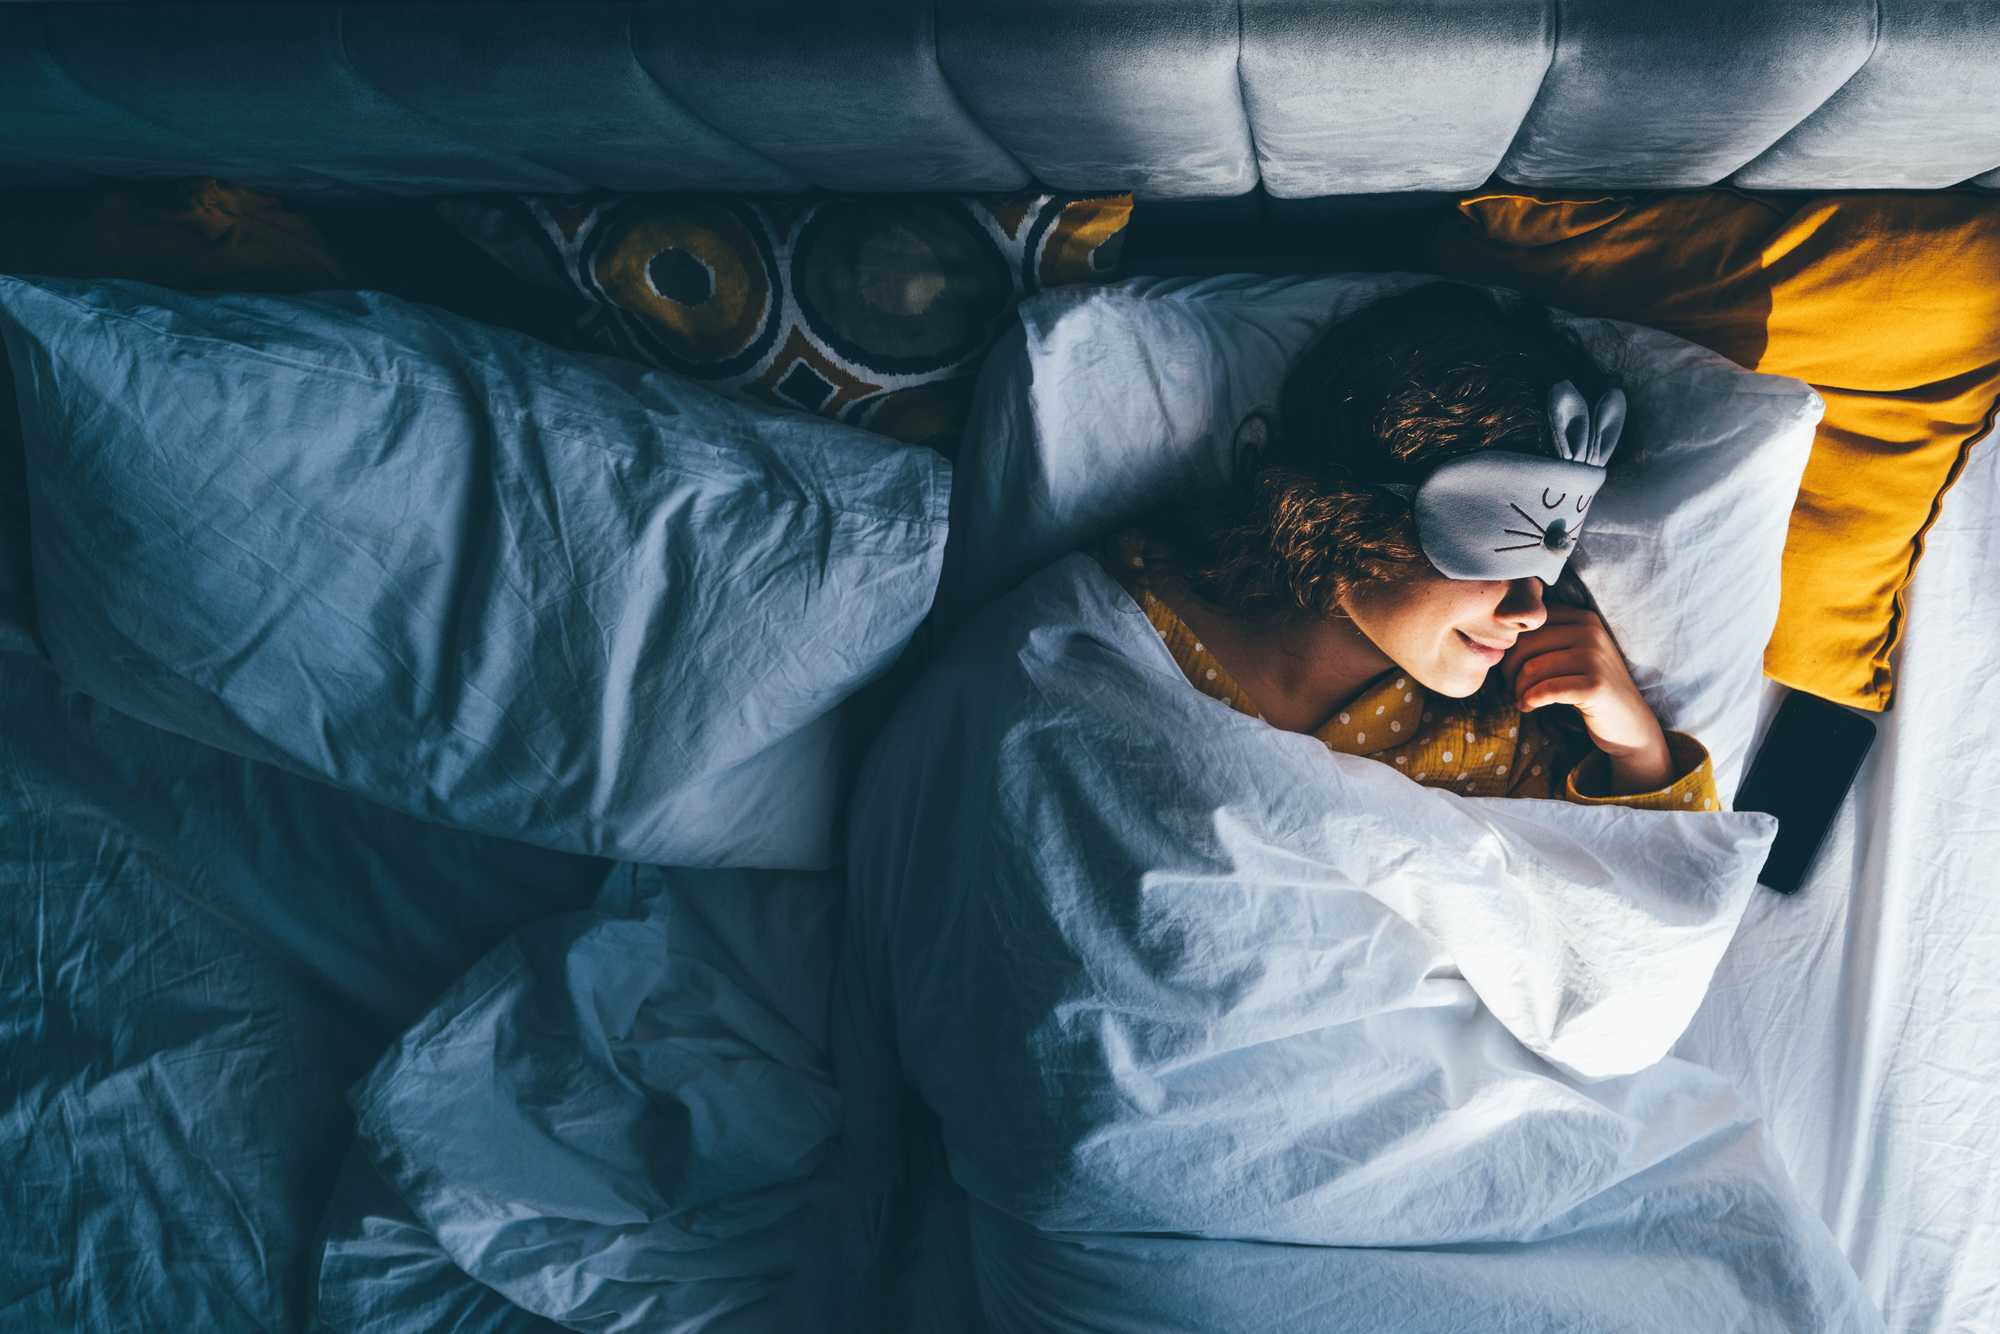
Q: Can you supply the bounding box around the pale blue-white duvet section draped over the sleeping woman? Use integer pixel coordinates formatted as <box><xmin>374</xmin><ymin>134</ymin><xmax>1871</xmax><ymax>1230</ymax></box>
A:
<box><xmin>838</xmin><ymin>556</ymin><xmax>1878</xmax><ymax>1330</ymax></box>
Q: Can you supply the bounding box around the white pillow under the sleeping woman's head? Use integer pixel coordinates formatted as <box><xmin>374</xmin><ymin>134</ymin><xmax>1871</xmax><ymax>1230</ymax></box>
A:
<box><xmin>938</xmin><ymin>274</ymin><xmax>1824</xmax><ymax>798</ymax></box>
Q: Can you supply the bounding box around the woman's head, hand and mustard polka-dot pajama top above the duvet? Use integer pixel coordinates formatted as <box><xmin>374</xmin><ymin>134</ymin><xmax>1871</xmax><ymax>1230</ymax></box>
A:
<box><xmin>1100</xmin><ymin>284</ymin><xmax>1716</xmax><ymax>810</ymax></box>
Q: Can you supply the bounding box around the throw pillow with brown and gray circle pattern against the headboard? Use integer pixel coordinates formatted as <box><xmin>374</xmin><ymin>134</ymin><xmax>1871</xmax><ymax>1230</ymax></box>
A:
<box><xmin>438</xmin><ymin>194</ymin><xmax>1132</xmax><ymax>454</ymax></box>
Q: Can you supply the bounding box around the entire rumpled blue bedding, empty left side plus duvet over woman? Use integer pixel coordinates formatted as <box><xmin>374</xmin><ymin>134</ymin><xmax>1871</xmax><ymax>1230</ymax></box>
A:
<box><xmin>0</xmin><ymin>290</ymin><xmax>1878</xmax><ymax>1334</ymax></box>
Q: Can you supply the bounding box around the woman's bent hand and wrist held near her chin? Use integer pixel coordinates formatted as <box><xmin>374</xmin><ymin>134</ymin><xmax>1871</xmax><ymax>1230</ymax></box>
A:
<box><xmin>1500</xmin><ymin>602</ymin><xmax>1674</xmax><ymax>796</ymax></box>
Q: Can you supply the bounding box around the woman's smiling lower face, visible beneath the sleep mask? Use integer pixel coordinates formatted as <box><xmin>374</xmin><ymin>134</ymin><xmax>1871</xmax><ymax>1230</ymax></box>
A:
<box><xmin>1340</xmin><ymin>566</ymin><xmax>1548</xmax><ymax>698</ymax></box>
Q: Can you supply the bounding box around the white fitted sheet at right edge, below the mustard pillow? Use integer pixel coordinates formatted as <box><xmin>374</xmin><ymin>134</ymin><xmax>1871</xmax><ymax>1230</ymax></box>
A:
<box><xmin>1676</xmin><ymin>430</ymin><xmax>2000</xmax><ymax>1334</ymax></box>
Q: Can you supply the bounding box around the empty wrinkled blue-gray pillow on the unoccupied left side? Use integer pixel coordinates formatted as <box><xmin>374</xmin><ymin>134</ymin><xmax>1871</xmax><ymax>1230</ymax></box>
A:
<box><xmin>0</xmin><ymin>278</ymin><xmax>950</xmax><ymax>870</ymax></box>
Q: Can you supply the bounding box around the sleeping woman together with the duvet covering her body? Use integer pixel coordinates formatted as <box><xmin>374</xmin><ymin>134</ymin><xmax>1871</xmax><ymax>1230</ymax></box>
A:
<box><xmin>834</xmin><ymin>288</ymin><xmax>1880</xmax><ymax>1330</ymax></box>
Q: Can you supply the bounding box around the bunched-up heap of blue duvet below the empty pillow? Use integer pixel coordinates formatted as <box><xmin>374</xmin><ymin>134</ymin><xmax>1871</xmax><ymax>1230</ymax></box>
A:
<box><xmin>320</xmin><ymin>868</ymin><xmax>864</xmax><ymax>1334</ymax></box>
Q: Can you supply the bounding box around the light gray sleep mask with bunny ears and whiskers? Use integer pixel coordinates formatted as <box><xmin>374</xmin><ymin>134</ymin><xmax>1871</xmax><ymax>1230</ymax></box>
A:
<box><xmin>1382</xmin><ymin>380</ymin><xmax>1626</xmax><ymax>584</ymax></box>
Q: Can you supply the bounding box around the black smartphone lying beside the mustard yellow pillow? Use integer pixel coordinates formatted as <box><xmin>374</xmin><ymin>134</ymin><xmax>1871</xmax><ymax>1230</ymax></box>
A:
<box><xmin>1736</xmin><ymin>690</ymin><xmax>1874</xmax><ymax>894</ymax></box>
